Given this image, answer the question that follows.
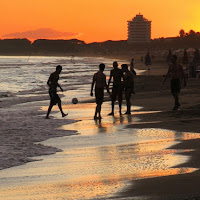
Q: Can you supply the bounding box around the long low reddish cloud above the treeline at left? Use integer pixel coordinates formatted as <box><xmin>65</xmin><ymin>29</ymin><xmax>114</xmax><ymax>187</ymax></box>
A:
<box><xmin>2</xmin><ymin>28</ymin><xmax>80</xmax><ymax>40</ymax></box>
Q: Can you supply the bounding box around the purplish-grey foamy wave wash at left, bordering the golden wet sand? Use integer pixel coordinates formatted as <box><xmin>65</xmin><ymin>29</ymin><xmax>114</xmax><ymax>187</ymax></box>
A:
<box><xmin>0</xmin><ymin>94</ymin><xmax>77</xmax><ymax>170</ymax></box>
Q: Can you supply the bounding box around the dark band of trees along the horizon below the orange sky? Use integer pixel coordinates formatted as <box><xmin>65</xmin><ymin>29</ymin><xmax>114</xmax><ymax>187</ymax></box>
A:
<box><xmin>0</xmin><ymin>30</ymin><xmax>200</xmax><ymax>56</ymax></box>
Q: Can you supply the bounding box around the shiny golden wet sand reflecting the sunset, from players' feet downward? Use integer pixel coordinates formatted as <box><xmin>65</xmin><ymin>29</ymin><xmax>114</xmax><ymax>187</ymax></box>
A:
<box><xmin>0</xmin><ymin>103</ymin><xmax>200</xmax><ymax>200</ymax></box>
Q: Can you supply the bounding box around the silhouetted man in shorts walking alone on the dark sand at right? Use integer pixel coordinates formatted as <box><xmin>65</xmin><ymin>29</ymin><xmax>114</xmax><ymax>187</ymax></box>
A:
<box><xmin>163</xmin><ymin>55</ymin><xmax>186</xmax><ymax>110</ymax></box>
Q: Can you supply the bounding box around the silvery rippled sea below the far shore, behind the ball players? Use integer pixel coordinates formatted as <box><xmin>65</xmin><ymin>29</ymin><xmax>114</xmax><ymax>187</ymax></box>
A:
<box><xmin>0</xmin><ymin>56</ymin><xmax>112</xmax><ymax>95</ymax></box>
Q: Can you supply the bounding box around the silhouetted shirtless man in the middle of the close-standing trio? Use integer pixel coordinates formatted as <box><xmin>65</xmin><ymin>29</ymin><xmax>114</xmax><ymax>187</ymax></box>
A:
<box><xmin>108</xmin><ymin>61</ymin><xmax>123</xmax><ymax>115</ymax></box>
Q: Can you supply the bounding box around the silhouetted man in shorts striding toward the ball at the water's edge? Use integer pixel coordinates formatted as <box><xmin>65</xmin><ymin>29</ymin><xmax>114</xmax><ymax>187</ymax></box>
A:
<box><xmin>46</xmin><ymin>65</ymin><xmax>67</xmax><ymax>119</ymax></box>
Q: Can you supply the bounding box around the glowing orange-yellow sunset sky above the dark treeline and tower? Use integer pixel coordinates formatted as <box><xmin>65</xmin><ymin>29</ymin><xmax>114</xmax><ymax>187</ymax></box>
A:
<box><xmin>0</xmin><ymin>0</ymin><xmax>200</xmax><ymax>43</ymax></box>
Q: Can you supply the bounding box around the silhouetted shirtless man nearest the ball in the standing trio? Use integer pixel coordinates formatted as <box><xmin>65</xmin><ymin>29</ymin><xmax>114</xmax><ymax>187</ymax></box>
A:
<box><xmin>90</xmin><ymin>63</ymin><xmax>110</xmax><ymax>120</ymax></box>
